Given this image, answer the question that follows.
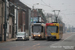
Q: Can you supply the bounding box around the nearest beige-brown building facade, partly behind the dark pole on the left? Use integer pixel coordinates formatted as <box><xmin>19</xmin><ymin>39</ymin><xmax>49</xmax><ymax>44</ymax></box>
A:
<box><xmin>0</xmin><ymin>0</ymin><xmax>16</xmax><ymax>41</ymax></box>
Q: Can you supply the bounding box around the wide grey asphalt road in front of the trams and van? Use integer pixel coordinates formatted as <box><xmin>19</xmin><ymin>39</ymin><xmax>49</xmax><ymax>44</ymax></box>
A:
<box><xmin>0</xmin><ymin>33</ymin><xmax>75</xmax><ymax>50</ymax></box>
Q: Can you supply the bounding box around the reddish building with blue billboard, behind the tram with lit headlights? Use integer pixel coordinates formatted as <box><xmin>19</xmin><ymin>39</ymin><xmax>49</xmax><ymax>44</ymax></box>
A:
<box><xmin>31</xmin><ymin>9</ymin><xmax>46</xmax><ymax>23</ymax></box>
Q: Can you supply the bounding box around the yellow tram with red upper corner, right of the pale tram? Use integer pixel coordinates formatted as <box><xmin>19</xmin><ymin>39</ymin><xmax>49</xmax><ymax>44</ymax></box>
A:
<box><xmin>45</xmin><ymin>23</ymin><xmax>63</xmax><ymax>40</ymax></box>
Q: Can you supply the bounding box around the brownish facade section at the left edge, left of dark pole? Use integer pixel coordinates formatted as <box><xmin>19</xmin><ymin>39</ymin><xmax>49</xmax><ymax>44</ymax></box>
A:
<box><xmin>0</xmin><ymin>0</ymin><xmax>5</xmax><ymax>41</ymax></box>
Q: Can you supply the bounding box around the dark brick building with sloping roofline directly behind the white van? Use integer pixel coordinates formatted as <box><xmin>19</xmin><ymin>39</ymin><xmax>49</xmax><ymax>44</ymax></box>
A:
<box><xmin>13</xmin><ymin>0</ymin><xmax>31</xmax><ymax>33</ymax></box>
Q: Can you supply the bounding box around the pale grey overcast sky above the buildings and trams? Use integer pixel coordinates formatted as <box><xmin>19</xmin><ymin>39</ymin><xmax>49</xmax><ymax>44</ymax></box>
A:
<box><xmin>20</xmin><ymin>0</ymin><xmax>75</xmax><ymax>27</ymax></box>
